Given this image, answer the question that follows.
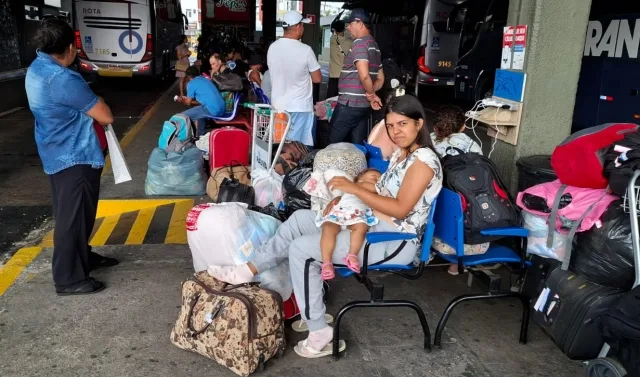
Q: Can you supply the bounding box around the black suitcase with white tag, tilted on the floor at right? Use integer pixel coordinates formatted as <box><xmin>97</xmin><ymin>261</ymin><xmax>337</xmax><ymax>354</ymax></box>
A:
<box><xmin>532</xmin><ymin>268</ymin><xmax>624</xmax><ymax>360</ymax></box>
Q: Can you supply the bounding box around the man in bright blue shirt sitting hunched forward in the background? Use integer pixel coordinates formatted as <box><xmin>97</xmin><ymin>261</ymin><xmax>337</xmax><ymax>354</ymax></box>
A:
<box><xmin>178</xmin><ymin>66</ymin><xmax>225</xmax><ymax>136</ymax></box>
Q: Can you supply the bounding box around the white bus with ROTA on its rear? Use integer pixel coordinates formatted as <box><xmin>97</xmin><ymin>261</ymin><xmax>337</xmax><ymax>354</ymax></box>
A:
<box><xmin>73</xmin><ymin>0</ymin><xmax>188</xmax><ymax>77</ymax></box>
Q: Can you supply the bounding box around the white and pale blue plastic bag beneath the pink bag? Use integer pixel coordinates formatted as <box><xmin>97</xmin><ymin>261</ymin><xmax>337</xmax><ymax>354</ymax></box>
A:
<box><xmin>522</xmin><ymin>211</ymin><xmax>567</xmax><ymax>261</ymax></box>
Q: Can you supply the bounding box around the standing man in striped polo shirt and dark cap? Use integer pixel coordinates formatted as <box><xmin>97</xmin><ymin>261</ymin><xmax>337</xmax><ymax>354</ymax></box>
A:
<box><xmin>331</xmin><ymin>9</ymin><xmax>384</xmax><ymax>143</ymax></box>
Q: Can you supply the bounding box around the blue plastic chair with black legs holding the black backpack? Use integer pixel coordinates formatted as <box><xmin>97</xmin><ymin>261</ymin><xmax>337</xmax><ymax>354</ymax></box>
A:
<box><xmin>434</xmin><ymin>188</ymin><xmax>529</xmax><ymax>348</ymax></box>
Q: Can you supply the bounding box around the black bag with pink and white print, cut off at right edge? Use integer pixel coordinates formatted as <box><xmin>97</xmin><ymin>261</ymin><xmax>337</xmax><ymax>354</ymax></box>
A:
<box><xmin>603</xmin><ymin>132</ymin><xmax>640</xmax><ymax>196</ymax></box>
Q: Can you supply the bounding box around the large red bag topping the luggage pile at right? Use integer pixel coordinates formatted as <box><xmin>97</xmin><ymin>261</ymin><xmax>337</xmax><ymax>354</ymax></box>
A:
<box><xmin>551</xmin><ymin>123</ymin><xmax>639</xmax><ymax>189</ymax></box>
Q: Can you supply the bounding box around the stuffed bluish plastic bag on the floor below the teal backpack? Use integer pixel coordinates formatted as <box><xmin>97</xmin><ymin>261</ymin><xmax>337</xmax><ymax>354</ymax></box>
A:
<box><xmin>144</xmin><ymin>147</ymin><xmax>207</xmax><ymax>196</ymax></box>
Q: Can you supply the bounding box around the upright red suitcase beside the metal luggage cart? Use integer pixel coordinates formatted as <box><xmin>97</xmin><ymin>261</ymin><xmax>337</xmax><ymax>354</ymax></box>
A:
<box><xmin>209</xmin><ymin>127</ymin><xmax>251</xmax><ymax>171</ymax></box>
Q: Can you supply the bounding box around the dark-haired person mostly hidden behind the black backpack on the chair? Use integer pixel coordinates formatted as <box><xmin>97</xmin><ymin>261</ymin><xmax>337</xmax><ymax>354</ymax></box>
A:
<box><xmin>431</xmin><ymin>105</ymin><xmax>489</xmax><ymax>275</ymax></box>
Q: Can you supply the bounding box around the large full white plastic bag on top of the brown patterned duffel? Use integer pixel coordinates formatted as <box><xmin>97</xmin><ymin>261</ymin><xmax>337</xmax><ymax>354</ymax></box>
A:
<box><xmin>186</xmin><ymin>203</ymin><xmax>281</xmax><ymax>272</ymax></box>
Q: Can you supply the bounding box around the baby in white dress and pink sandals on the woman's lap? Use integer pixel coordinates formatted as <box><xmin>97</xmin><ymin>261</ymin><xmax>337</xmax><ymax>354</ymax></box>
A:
<box><xmin>316</xmin><ymin>169</ymin><xmax>381</xmax><ymax>280</ymax></box>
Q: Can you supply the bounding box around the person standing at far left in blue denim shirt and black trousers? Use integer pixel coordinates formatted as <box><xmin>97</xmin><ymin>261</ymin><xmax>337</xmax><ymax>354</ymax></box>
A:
<box><xmin>25</xmin><ymin>19</ymin><xmax>118</xmax><ymax>295</ymax></box>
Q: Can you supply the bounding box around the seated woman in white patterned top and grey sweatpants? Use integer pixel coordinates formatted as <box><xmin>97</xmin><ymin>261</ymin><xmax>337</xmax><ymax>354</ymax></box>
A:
<box><xmin>209</xmin><ymin>90</ymin><xmax>442</xmax><ymax>358</ymax></box>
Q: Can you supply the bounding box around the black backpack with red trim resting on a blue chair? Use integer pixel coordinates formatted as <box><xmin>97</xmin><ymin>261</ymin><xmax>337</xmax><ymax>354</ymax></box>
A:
<box><xmin>443</xmin><ymin>148</ymin><xmax>520</xmax><ymax>245</ymax></box>
